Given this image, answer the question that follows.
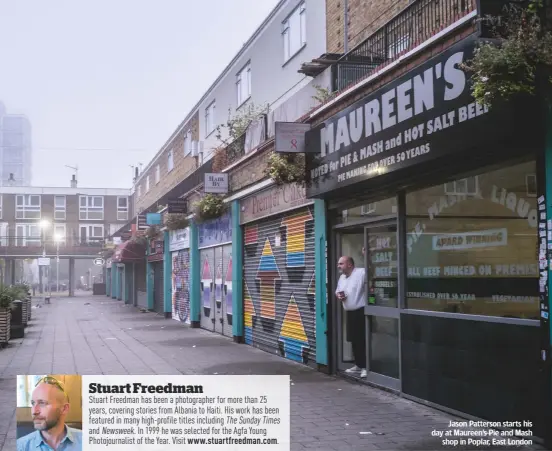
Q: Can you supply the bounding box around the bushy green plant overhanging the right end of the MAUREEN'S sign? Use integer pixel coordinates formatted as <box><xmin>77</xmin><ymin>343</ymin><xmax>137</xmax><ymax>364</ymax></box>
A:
<box><xmin>461</xmin><ymin>4</ymin><xmax>552</xmax><ymax>106</ymax></box>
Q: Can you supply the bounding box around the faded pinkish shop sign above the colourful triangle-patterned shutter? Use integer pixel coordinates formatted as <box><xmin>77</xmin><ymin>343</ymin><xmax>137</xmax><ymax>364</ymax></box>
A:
<box><xmin>240</xmin><ymin>184</ymin><xmax>313</xmax><ymax>224</ymax></box>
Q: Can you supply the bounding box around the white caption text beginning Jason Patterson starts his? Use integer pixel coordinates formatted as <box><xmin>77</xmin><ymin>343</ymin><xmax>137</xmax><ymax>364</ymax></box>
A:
<box><xmin>431</xmin><ymin>420</ymin><xmax>533</xmax><ymax>449</ymax></box>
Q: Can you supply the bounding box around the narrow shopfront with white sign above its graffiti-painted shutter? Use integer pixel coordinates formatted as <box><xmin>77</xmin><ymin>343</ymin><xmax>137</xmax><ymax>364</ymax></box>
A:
<box><xmin>169</xmin><ymin>227</ymin><xmax>190</xmax><ymax>324</ymax></box>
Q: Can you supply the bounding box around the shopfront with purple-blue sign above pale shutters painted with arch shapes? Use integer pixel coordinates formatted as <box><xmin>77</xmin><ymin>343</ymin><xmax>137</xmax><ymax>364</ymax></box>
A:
<box><xmin>199</xmin><ymin>213</ymin><xmax>233</xmax><ymax>337</ymax></box>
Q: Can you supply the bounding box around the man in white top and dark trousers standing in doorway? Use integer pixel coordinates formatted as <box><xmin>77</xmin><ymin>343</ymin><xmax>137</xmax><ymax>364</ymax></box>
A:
<box><xmin>335</xmin><ymin>256</ymin><xmax>366</xmax><ymax>378</ymax></box>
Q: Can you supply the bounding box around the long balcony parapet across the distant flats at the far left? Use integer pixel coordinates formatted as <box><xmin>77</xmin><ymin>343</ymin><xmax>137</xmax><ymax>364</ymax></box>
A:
<box><xmin>0</xmin><ymin>237</ymin><xmax>104</xmax><ymax>258</ymax></box>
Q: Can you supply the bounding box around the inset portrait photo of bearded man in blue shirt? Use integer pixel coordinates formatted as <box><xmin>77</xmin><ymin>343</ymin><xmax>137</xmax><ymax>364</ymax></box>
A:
<box><xmin>16</xmin><ymin>375</ymin><xmax>82</xmax><ymax>451</ymax></box>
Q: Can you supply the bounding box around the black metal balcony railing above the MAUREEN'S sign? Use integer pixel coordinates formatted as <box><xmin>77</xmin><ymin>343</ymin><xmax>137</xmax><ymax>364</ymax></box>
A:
<box><xmin>332</xmin><ymin>0</ymin><xmax>477</xmax><ymax>91</ymax></box>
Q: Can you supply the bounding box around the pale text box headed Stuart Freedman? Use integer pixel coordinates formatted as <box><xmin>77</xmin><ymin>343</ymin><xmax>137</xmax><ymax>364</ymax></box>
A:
<box><xmin>82</xmin><ymin>375</ymin><xmax>290</xmax><ymax>451</ymax></box>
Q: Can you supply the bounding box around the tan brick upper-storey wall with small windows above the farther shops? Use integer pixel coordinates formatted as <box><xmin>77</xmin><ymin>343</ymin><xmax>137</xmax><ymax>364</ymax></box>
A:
<box><xmin>134</xmin><ymin>113</ymin><xmax>199</xmax><ymax>213</ymax></box>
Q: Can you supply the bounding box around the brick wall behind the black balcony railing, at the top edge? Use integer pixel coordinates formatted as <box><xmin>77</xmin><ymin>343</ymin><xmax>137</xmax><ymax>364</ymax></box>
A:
<box><xmin>326</xmin><ymin>0</ymin><xmax>410</xmax><ymax>53</ymax></box>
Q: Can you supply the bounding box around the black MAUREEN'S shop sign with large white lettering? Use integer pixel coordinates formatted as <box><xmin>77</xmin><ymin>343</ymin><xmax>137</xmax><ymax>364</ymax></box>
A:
<box><xmin>305</xmin><ymin>38</ymin><xmax>504</xmax><ymax>197</ymax></box>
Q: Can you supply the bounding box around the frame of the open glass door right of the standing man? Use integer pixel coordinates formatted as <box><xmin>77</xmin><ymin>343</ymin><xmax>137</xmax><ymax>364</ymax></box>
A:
<box><xmin>364</xmin><ymin>222</ymin><xmax>403</xmax><ymax>391</ymax></box>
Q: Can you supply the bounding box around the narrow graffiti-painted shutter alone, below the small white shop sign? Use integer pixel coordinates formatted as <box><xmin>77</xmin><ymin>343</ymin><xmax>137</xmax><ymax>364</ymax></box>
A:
<box><xmin>172</xmin><ymin>249</ymin><xmax>190</xmax><ymax>324</ymax></box>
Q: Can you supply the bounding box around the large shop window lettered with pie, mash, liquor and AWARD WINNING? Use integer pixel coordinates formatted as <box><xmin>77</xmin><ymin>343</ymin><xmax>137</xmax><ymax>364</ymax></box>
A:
<box><xmin>406</xmin><ymin>162</ymin><xmax>539</xmax><ymax>319</ymax></box>
